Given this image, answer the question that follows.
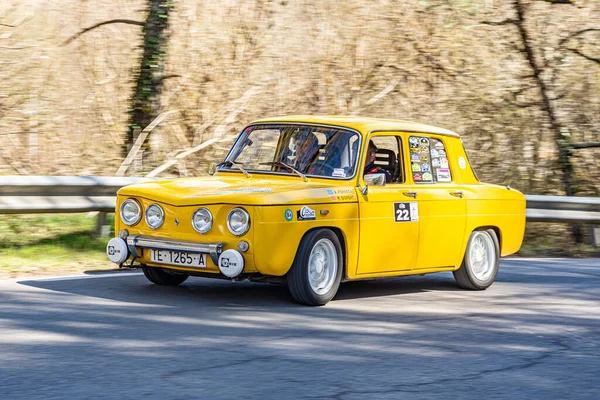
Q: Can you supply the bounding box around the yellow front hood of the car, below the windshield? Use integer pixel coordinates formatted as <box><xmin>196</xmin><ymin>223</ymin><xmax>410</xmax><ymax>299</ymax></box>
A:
<box><xmin>117</xmin><ymin>175</ymin><xmax>358</xmax><ymax>206</ymax></box>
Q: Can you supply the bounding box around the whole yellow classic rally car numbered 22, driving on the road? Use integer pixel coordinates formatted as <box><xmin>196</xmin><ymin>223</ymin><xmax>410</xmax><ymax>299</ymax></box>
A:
<box><xmin>107</xmin><ymin>116</ymin><xmax>525</xmax><ymax>305</ymax></box>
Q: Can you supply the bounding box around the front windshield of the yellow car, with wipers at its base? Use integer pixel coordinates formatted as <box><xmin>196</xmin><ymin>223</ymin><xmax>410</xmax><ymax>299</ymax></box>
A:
<box><xmin>220</xmin><ymin>124</ymin><xmax>360</xmax><ymax>179</ymax></box>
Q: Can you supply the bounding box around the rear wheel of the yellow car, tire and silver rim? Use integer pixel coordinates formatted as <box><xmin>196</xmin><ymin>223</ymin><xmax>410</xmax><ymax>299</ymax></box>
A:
<box><xmin>452</xmin><ymin>229</ymin><xmax>500</xmax><ymax>290</ymax></box>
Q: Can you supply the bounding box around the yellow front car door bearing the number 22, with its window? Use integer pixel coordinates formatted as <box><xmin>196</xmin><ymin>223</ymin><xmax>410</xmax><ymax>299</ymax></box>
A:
<box><xmin>356</xmin><ymin>133</ymin><xmax>419</xmax><ymax>275</ymax></box>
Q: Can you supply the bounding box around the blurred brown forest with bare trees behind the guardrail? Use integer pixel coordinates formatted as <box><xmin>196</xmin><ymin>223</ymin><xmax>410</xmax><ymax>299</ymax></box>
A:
<box><xmin>0</xmin><ymin>0</ymin><xmax>600</xmax><ymax>258</ymax></box>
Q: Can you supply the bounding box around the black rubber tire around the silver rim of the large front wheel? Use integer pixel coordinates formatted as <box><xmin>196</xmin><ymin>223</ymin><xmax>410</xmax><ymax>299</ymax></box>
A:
<box><xmin>286</xmin><ymin>229</ymin><xmax>344</xmax><ymax>306</ymax></box>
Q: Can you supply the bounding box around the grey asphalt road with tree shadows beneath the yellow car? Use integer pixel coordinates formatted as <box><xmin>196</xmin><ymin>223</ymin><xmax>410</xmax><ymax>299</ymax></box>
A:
<box><xmin>0</xmin><ymin>259</ymin><xmax>600</xmax><ymax>400</ymax></box>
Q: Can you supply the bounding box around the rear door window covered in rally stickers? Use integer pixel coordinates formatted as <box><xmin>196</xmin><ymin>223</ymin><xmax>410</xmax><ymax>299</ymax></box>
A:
<box><xmin>408</xmin><ymin>136</ymin><xmax>452</xmax><ymax>183</ymax></box>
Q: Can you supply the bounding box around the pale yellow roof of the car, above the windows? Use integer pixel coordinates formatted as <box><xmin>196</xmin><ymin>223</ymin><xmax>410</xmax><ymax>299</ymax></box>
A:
<box><xmin>250</xmin><ymin>115</ymin><xmax>460</xmax><ymax>137</ymax></box>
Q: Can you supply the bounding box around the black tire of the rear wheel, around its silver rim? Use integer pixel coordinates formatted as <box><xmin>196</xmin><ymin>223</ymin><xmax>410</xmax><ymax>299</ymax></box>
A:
<box><xmin>452</xmin><ymin>229</ymin><xmax>500</xmax><ymax>290</ymax></box>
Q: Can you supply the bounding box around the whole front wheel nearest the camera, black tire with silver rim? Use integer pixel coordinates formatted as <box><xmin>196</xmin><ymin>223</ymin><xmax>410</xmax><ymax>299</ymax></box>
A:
<box><xmin>287</xmin><ymin>229</ymin><xmax>343</xmax><ymax>306</ymax></box>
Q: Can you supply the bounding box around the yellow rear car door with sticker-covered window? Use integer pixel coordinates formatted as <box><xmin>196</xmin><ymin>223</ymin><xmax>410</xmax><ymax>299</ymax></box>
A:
<box><xmin>406</xmin><ymin>134</ymin><xmax>466</xmax><ymax>269</ymax></box>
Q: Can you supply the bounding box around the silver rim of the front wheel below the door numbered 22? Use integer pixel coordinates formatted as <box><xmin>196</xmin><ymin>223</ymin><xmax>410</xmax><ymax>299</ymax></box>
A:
<box><xmin>308</xmin><ymin>239</ymin><xmax>337</xmax><ymax>295</ymax></box>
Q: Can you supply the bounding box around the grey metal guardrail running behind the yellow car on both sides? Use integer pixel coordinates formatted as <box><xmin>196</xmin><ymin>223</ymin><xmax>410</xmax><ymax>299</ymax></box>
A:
<box><xmin>0</xmin><ymin>176</ymin><xmax>600</xmax><ymax>234</ymax></box>
